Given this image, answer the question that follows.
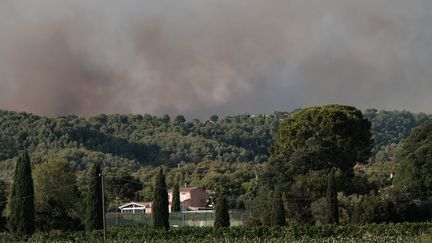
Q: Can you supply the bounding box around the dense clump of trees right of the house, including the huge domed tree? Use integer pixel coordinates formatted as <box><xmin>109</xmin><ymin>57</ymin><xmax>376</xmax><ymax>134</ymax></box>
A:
<box><xmin>248</xmin><ymin>105</ymin><xmax>432</xmax><ymax>225</ymax></box>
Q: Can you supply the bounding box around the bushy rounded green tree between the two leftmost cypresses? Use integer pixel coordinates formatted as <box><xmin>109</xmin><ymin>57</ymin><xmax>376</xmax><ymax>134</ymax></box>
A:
<box><xmin>33</xmin><ymin>160</ymin><xmax>80</xmax><ymax>230</ymax></box>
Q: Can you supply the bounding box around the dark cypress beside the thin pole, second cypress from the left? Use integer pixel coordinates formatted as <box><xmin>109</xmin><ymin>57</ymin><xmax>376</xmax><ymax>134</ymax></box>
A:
<box><xmin>85</xmin><ymin>164</ymin><xmax>103</xmax><ymax>231</ymax></box>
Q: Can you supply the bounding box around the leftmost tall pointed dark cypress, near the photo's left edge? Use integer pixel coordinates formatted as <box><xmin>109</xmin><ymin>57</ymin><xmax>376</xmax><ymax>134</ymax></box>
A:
<box><xmin>8</xmin><ymin>152</ymin><xmax>35</xmax><ymax>236</ymax></box>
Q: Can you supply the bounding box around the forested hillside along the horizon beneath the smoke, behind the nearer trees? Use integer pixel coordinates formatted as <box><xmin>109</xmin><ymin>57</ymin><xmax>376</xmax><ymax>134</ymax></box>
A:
<box><xmin>0</xmin><ymin>109</ymin><xmax>429</xmax><ymax>179</ymax></box>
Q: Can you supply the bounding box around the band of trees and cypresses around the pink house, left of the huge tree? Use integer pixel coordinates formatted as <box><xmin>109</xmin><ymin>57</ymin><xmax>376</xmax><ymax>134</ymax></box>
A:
<box><xmin>0</xmin><ymin>152</ymin><xmax>240</xmax><ymax>236</ymax></box>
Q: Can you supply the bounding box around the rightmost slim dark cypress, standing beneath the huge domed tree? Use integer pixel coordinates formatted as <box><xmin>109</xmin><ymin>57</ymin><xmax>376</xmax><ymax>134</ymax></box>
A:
<box><xmin>326</xmin><ymin>168</ymin><xmax>339</xmax><ymax>224</ymax></box>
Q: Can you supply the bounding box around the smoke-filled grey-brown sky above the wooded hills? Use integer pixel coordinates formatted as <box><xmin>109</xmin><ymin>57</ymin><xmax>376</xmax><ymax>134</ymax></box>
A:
<box><xmin>0</xmin><ymin>0</ymin><xmax>432</xmax><ymax>118</ymax></box>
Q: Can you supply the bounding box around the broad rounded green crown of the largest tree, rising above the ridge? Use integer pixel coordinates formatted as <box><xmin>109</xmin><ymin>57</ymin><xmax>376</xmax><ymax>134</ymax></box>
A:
<box><xmin>270</xmin><ymin>105</ymin><xmax>372</xmax><ymax>192</ymax></box>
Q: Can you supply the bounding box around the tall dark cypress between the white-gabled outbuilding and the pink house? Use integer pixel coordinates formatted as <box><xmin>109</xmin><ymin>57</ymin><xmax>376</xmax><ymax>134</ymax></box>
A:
<box><xmin>152</xmin><ymin>169</ymin><xmax>169</xmax><ymax>229</ymax></box>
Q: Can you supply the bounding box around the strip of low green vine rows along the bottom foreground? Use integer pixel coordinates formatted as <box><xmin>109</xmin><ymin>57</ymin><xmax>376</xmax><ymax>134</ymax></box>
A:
<box><xmin>1</xmin><ymin>223</ymin><xmax>432</xmax><ymax>243</ymax></box>
